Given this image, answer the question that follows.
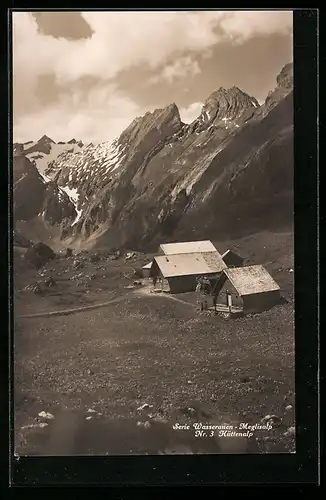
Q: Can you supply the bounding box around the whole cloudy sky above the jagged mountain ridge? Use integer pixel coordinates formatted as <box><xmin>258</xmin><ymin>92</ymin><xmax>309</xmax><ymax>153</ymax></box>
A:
<box><xmin>12</xmin><ymin>11</ymin><xmax>293</xmax><ymax>143</ymax></box>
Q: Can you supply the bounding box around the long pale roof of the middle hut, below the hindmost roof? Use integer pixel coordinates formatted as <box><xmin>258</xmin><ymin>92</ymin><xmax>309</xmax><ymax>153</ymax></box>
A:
<box><xmin>154</xmin><ymin>251</ymin><xmax>226</xmax><ymax>278</ymax></box>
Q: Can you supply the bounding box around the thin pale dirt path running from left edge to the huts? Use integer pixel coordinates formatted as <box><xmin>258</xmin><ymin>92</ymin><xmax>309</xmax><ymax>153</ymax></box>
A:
<box><xmin>17</xmin><ymin>289</ymin><xmax>193</xmax><ymax>319</ymax></box>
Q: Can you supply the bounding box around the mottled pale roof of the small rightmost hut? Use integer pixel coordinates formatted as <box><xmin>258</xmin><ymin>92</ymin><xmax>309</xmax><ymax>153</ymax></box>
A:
<box><xmin>223</xmin><ymin>266</ymin><xmax>280</xmax><ymax>296</ymax></box>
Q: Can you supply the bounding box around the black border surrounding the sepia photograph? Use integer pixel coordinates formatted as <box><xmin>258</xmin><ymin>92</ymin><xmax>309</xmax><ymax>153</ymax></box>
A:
<box><xmin>0</xmin><ymin>6</ymin><xmax>320</xmax><ymax>487</ymax></box>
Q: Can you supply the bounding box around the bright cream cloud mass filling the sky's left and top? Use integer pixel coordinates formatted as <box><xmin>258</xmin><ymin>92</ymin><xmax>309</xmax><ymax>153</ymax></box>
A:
<box><xmin>13</xmin><ymin>11</ymin><xmax>292</xmax><ymax>140</ymax></box>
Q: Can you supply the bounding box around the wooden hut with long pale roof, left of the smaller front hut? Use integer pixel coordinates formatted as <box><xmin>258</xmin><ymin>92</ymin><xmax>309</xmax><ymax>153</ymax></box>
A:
<box><xmin>152</xmin><ymin>251</ymin><xmax>226</xmax><ymax>293</ymax></box>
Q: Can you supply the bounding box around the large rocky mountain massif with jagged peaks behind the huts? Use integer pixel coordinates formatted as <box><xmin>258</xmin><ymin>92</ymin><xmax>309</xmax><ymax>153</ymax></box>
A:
<box><xmin>14</xmin><ymin>64</ymin><xmax>293</xmax><ymax>249</ymax></box>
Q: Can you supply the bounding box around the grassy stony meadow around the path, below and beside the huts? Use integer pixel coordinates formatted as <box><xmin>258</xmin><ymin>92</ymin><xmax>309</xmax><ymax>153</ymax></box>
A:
<box><xmin>14</xmin><ymin>229</ymin><xmax>295</xmax><ymax>455</ymax></box>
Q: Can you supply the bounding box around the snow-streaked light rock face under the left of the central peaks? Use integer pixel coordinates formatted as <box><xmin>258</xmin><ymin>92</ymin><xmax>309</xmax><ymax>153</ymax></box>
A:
<box><xmin>45</xmin><ymin>104</ymin><xmax>184</xmax><ymax>238</ymax></box>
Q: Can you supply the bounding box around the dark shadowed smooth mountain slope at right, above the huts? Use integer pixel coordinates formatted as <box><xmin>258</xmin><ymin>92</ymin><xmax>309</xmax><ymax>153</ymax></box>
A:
<box><xmin>177</xmin><ymin>92</ymin><xmax>293</xmax><ymax>242</ymax></box>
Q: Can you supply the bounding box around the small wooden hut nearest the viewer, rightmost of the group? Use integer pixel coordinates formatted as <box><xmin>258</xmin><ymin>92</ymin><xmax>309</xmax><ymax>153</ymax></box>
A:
<box><xmin>213</xmin><ymin>265</ymin><xmax>281</xmax><ymax>314</ymax></box>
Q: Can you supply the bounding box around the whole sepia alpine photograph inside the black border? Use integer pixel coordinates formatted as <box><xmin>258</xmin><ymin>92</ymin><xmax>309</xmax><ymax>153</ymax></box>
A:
<box><xmin>11</xmin><ymin>10</ymin><xmax>296</xmax><ymax>456</ymax></box>
